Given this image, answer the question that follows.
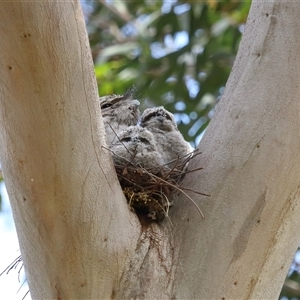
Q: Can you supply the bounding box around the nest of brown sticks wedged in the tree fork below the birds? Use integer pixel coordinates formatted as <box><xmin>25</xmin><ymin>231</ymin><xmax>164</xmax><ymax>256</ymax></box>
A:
<box><xmin>111</xmin><ymin>151</ymin><xmax>206</xmax><ymax>221</ymax></box>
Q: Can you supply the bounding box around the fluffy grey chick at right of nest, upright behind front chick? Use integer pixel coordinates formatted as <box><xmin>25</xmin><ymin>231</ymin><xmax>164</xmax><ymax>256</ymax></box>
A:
<box><xmin>140</xmin><ymin>106</ymin><xmax>193</xmax><ymax>169</ymax></box>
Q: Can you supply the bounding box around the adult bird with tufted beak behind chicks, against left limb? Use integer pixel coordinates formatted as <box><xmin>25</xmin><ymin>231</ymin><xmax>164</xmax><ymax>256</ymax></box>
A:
<box><xmin>100</xmin><ymin>89</ymin><xmax>140</xmax><ymax>146</ymax></box>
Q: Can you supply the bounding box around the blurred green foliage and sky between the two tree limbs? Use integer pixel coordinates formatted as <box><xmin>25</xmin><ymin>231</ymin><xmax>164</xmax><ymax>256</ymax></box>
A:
<box><xmin>0</xmin><ymin>1</ymin><xmax>298</xmax><ymax>298</ymax></box>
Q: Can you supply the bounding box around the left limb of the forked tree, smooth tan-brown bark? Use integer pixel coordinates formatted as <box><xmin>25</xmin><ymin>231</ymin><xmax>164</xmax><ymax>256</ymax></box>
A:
<box><xmin>0</xmin><ymin>1</ymin><xmax>139</xmax><ymax>299</ymax></box>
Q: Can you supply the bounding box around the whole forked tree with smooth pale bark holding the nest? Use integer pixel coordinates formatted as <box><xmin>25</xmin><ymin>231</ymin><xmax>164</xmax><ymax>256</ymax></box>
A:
<box><xmin>0</xmin><ymin>1</ymin><xmax>300</xmax><ymax>299</ymax></box>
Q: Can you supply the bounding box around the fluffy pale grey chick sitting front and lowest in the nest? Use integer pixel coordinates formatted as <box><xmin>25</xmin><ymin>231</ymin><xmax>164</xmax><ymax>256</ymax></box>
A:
<box><xmin>110</xmin><ymin>125</ymin><xmax>163</xmax><ymax>169</ymax></box>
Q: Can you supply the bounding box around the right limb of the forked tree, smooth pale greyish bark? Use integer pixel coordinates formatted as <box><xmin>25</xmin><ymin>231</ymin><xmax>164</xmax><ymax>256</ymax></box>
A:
<box><xmin>171</xmin><ymin>1</ymin><xmax>300</xmax><ymax>299</ymax></box>
